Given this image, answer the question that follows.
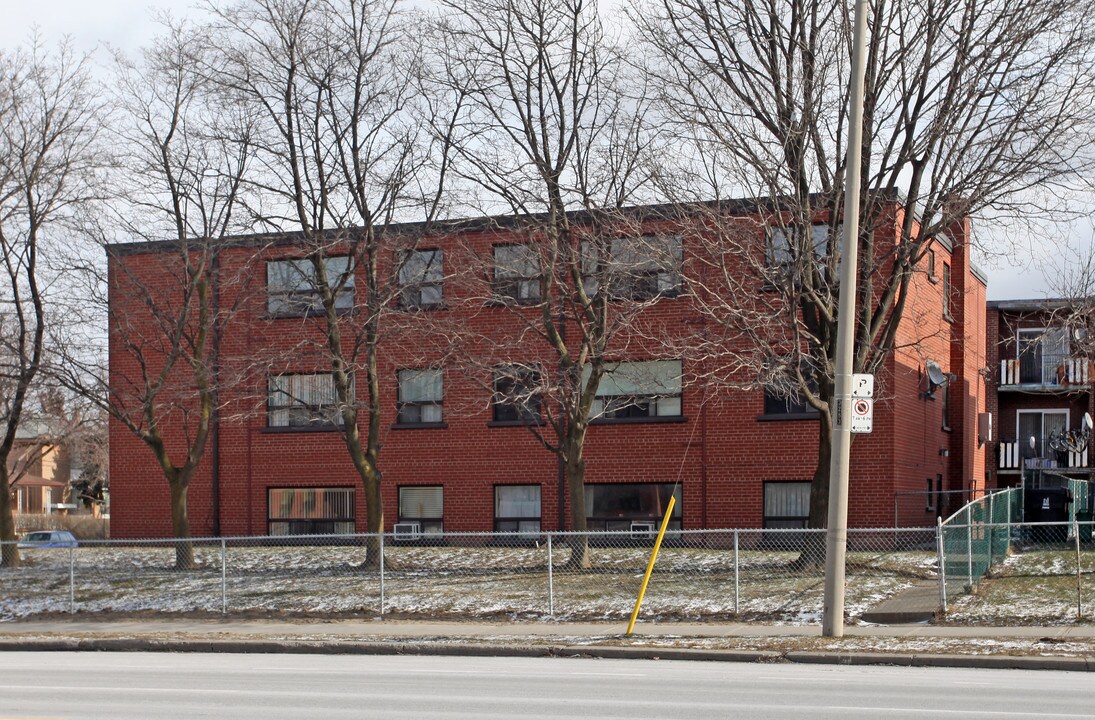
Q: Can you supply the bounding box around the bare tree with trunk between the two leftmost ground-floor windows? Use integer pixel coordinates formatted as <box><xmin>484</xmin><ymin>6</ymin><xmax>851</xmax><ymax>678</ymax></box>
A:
<box><xmin>206</xmin><ymin>0</ymin><xmax>439</xmax><ymax>569</ymax></box>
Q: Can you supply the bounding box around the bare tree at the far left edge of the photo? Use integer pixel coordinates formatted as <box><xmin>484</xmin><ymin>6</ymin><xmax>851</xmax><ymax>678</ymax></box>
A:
<box><xmin>0</xmin><ymin>40</ymin><xmax>99</xmax><ymax>567</ymax></box>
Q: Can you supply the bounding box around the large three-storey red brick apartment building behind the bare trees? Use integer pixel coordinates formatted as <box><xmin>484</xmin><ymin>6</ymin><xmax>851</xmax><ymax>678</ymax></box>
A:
<box><xmin>110</xmin><ymin>199</ymin><xmax>988</xmax><ymax>537</ymax></box>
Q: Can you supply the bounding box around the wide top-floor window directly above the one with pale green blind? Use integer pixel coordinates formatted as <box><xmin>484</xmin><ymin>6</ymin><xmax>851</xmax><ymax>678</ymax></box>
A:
<box><xmin>581</xmin><ymin>235</ymin><xmax>682</xmax><ymax>300</ymax></box>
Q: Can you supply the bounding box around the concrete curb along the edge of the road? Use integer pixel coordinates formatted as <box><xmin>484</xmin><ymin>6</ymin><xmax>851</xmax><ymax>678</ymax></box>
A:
<box><xmin>0</xmin><ymin>638</ymin><xmax>1095</xmax><ymax>672</ymax></box>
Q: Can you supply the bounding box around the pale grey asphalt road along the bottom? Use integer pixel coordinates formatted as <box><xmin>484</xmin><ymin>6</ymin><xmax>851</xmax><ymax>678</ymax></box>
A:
<box><xmin>0</xmin><ymin>652</ymin><xmax>1095</xmax><ymax>720</ymax></box>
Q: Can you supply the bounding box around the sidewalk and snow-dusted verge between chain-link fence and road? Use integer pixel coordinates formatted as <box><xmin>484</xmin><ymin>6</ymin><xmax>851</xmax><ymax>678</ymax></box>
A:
<box><xmin>0</xmin><ymin>618</ymin><xmax>1095</xmax><ymax>672</ymax></box>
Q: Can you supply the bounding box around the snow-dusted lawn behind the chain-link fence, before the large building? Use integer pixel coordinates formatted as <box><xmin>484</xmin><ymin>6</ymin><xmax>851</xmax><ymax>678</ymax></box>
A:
<box><xmin>0</xmin><ymin>544</ymin><xmax>934</xmax><ymax>623</ymax></box>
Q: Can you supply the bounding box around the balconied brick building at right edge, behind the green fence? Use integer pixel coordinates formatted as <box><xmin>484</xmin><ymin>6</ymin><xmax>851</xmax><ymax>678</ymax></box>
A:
<box><xmin>986</xmin><ymin>300</ymin><xmax>1095</xmax><ymax>488</ymax></box>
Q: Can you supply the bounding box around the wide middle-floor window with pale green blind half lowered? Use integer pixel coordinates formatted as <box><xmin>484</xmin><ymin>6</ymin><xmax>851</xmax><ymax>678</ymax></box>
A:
<box><xmin>584</xmin><ymin>360</ymin><xmax>681</xmax><ymax>420</ymax></box>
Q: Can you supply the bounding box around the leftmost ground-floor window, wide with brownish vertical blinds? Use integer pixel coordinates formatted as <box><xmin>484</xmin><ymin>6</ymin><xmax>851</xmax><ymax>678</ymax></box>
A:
<box><xmin>266</xmin><ymin>488</ymin><xmax>356</xmax><ymax>535</ymax></box>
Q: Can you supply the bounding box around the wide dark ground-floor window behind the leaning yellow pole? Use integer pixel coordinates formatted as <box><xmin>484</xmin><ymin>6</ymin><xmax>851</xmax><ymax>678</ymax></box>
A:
<box><xmin>586</xmin><ymin>483</ymin><xmax>683</xmax><ymax>533</ymax></box>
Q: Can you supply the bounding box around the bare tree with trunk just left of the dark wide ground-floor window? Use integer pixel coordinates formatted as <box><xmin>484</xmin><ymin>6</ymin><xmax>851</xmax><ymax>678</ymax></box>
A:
<box><xmin>431</xmin><ymin>0</ymin><xmax>661</xmax><ymax>567</ymax></box>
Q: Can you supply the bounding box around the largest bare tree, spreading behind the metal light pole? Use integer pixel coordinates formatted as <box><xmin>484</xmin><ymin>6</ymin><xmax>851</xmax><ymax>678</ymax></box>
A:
<box><xmin>632</xmin><ymin>0</ymin><xmax>1093</xmax><ymax>540</ymax></box>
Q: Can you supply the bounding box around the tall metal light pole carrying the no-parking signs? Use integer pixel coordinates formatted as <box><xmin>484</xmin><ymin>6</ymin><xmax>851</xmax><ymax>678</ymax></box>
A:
<box><xmin>821</xmin><ymin>0</ymin><xmax>868</xmax><ymax>638</ymax></box>
